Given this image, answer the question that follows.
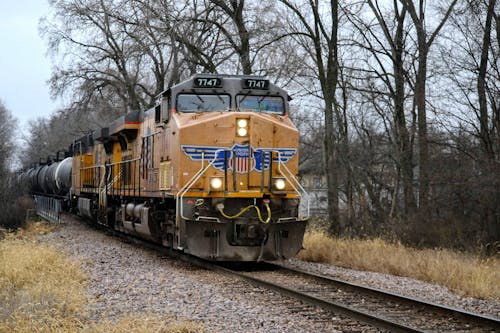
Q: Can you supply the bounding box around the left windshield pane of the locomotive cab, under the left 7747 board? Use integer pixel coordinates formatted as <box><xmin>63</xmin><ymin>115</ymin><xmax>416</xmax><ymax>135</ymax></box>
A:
<box><xmin>177</xmin><ymin>93</ymin><xmax>231</xmax><ymax>112</ymax></box>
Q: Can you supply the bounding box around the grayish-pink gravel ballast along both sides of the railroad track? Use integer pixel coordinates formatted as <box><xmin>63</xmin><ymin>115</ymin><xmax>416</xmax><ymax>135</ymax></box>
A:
<box><xmin>40</xmin><ymin>216</ymin><xmax>500</xmax><ymax>332</ymax></box>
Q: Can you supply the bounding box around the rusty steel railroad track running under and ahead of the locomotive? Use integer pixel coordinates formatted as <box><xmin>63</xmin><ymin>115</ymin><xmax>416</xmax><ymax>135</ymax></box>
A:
<box><xmin>59</xmin><ymin>214</ymin><xmax>500</xmax><ymax>332</ymax></box>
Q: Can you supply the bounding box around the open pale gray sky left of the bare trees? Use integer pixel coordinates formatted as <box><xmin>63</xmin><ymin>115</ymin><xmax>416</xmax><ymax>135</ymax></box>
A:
<box><xmin>0</xmin><ymin>0</ymin><xmax>57</xmax><ymax>129</ymax></box>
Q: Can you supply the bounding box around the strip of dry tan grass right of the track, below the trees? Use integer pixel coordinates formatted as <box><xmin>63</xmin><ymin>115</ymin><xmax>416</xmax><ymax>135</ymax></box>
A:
<box><xmin>299</xmin><ymin>231</ymin><xmax>500</xmax><ymax>300</ymax></box>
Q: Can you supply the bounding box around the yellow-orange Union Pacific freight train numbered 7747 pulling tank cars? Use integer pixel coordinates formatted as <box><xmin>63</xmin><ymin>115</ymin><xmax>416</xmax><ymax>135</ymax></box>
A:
<box><xmin>23</xmin><ymin>74</ymin><xmax>309</xmax><ymax>262</ymax></box>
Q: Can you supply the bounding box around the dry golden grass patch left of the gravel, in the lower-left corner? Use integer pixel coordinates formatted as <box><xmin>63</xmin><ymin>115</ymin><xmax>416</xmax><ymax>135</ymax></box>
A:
<box><xmin>0</xmin><ymin>222</ymin><xmax>204</xmax><ymax>333</ymax></box>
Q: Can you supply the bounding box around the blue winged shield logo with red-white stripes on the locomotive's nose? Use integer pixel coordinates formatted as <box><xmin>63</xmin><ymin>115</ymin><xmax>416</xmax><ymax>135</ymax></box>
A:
<box><xmin>181</xmin><ymin>144</ymin><xmax>297</xmax><ymax>173</ymax></box>
